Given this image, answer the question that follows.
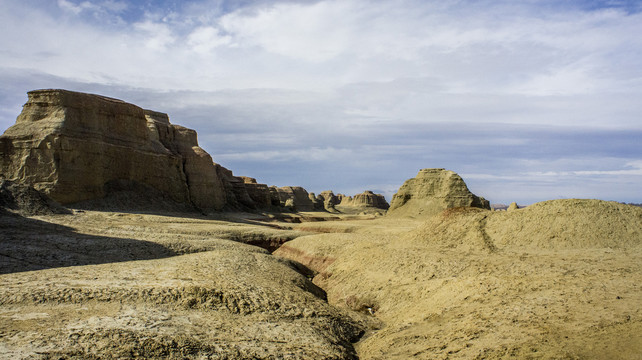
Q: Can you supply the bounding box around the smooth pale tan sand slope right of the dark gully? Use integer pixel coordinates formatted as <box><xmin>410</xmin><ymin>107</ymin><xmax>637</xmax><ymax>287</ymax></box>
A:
<box><xmin>275</xmin><ymin>200</ymin><xmax>642</xmax><ymax>359</ymax></box>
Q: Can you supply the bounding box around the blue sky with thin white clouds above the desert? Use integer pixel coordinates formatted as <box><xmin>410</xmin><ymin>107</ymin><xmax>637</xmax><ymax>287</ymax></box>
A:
<box><xmin>0</xmin><ymin>0</ymin><xmax>642</xmax><ymax>204</ymax></box>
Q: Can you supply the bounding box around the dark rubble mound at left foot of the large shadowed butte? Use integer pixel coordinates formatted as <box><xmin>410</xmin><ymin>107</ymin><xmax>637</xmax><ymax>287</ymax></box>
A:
<box><xmin>0</xmin><ymin>180</ymin><xmax>71</xmax><ymax>216</ymax></box>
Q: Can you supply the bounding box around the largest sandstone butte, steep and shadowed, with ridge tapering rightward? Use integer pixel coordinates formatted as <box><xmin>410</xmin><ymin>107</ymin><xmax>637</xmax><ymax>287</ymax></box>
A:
<box><xmin>0</xmin><ymin>90</ymin><xmax>388</xmax><ymax>211</ymax></box>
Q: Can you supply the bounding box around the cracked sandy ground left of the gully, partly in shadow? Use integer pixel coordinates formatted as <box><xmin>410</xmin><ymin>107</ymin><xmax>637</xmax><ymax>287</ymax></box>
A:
<box><xmin>0</xmin><ymin>211</ymin><xmax>366</xmax><ymax>359</ymax></box>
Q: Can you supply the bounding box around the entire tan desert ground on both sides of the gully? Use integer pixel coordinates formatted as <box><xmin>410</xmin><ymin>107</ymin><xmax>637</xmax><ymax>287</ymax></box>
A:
<box><xmin>0</xmin><ymin>200</ymin><xmax>642</xmax><ymax>359</ymax></box>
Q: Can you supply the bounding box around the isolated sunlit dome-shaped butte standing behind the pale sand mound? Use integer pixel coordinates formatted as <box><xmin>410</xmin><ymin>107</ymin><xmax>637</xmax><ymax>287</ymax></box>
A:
<box><xmin>388</xmin><ymin>169</ymin><xmax>490</xmax><ymax>217</ymax></box>
